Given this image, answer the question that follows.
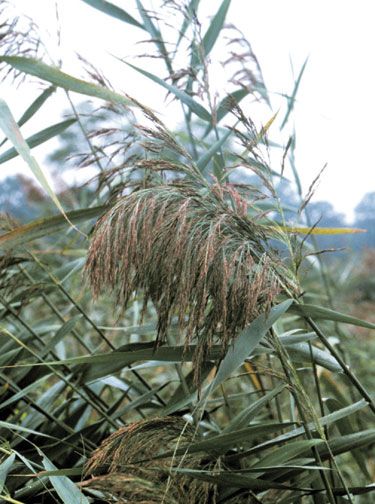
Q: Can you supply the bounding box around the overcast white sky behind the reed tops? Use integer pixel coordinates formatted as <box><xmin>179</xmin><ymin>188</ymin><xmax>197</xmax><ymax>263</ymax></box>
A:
<box><xmin>1</xmin><ymin>0</ymin><xmax>375</xmax><ymax>218</ymax></box>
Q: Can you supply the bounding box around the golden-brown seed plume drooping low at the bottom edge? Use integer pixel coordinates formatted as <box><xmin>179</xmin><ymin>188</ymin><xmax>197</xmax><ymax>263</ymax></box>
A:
<box><xmin>83</xmin><ymin>417</ymin><xmax>212</xmax><ymax>504</ymax></box>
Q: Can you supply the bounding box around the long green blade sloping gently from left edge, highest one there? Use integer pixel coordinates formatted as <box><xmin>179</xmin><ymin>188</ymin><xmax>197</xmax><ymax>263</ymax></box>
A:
<box><xmin>0</xmin><ymin>56</ymin><xmax>136</xmax><ymax>106</ymax></box>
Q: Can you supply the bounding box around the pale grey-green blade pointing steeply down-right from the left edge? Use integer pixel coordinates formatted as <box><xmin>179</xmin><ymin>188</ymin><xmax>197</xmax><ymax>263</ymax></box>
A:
<box><xmin>0</xmin><ymin>99</ymin><xmax>66</xmax><ymax>218</ymax></box>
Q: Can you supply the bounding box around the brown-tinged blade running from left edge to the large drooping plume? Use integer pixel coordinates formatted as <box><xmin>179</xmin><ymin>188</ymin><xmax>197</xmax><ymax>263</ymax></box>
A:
<box><xmin>0</xmin><ymin>206</ymin><xmax>106</xmax><ymax>250</ymax></box>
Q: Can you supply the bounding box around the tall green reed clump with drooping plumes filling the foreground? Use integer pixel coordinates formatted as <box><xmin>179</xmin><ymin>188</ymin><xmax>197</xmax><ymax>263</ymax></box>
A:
<box><xmin>0</xmin><ymin>0</ymin><xmax>375</xmax><ymax>504</ymax></box>
